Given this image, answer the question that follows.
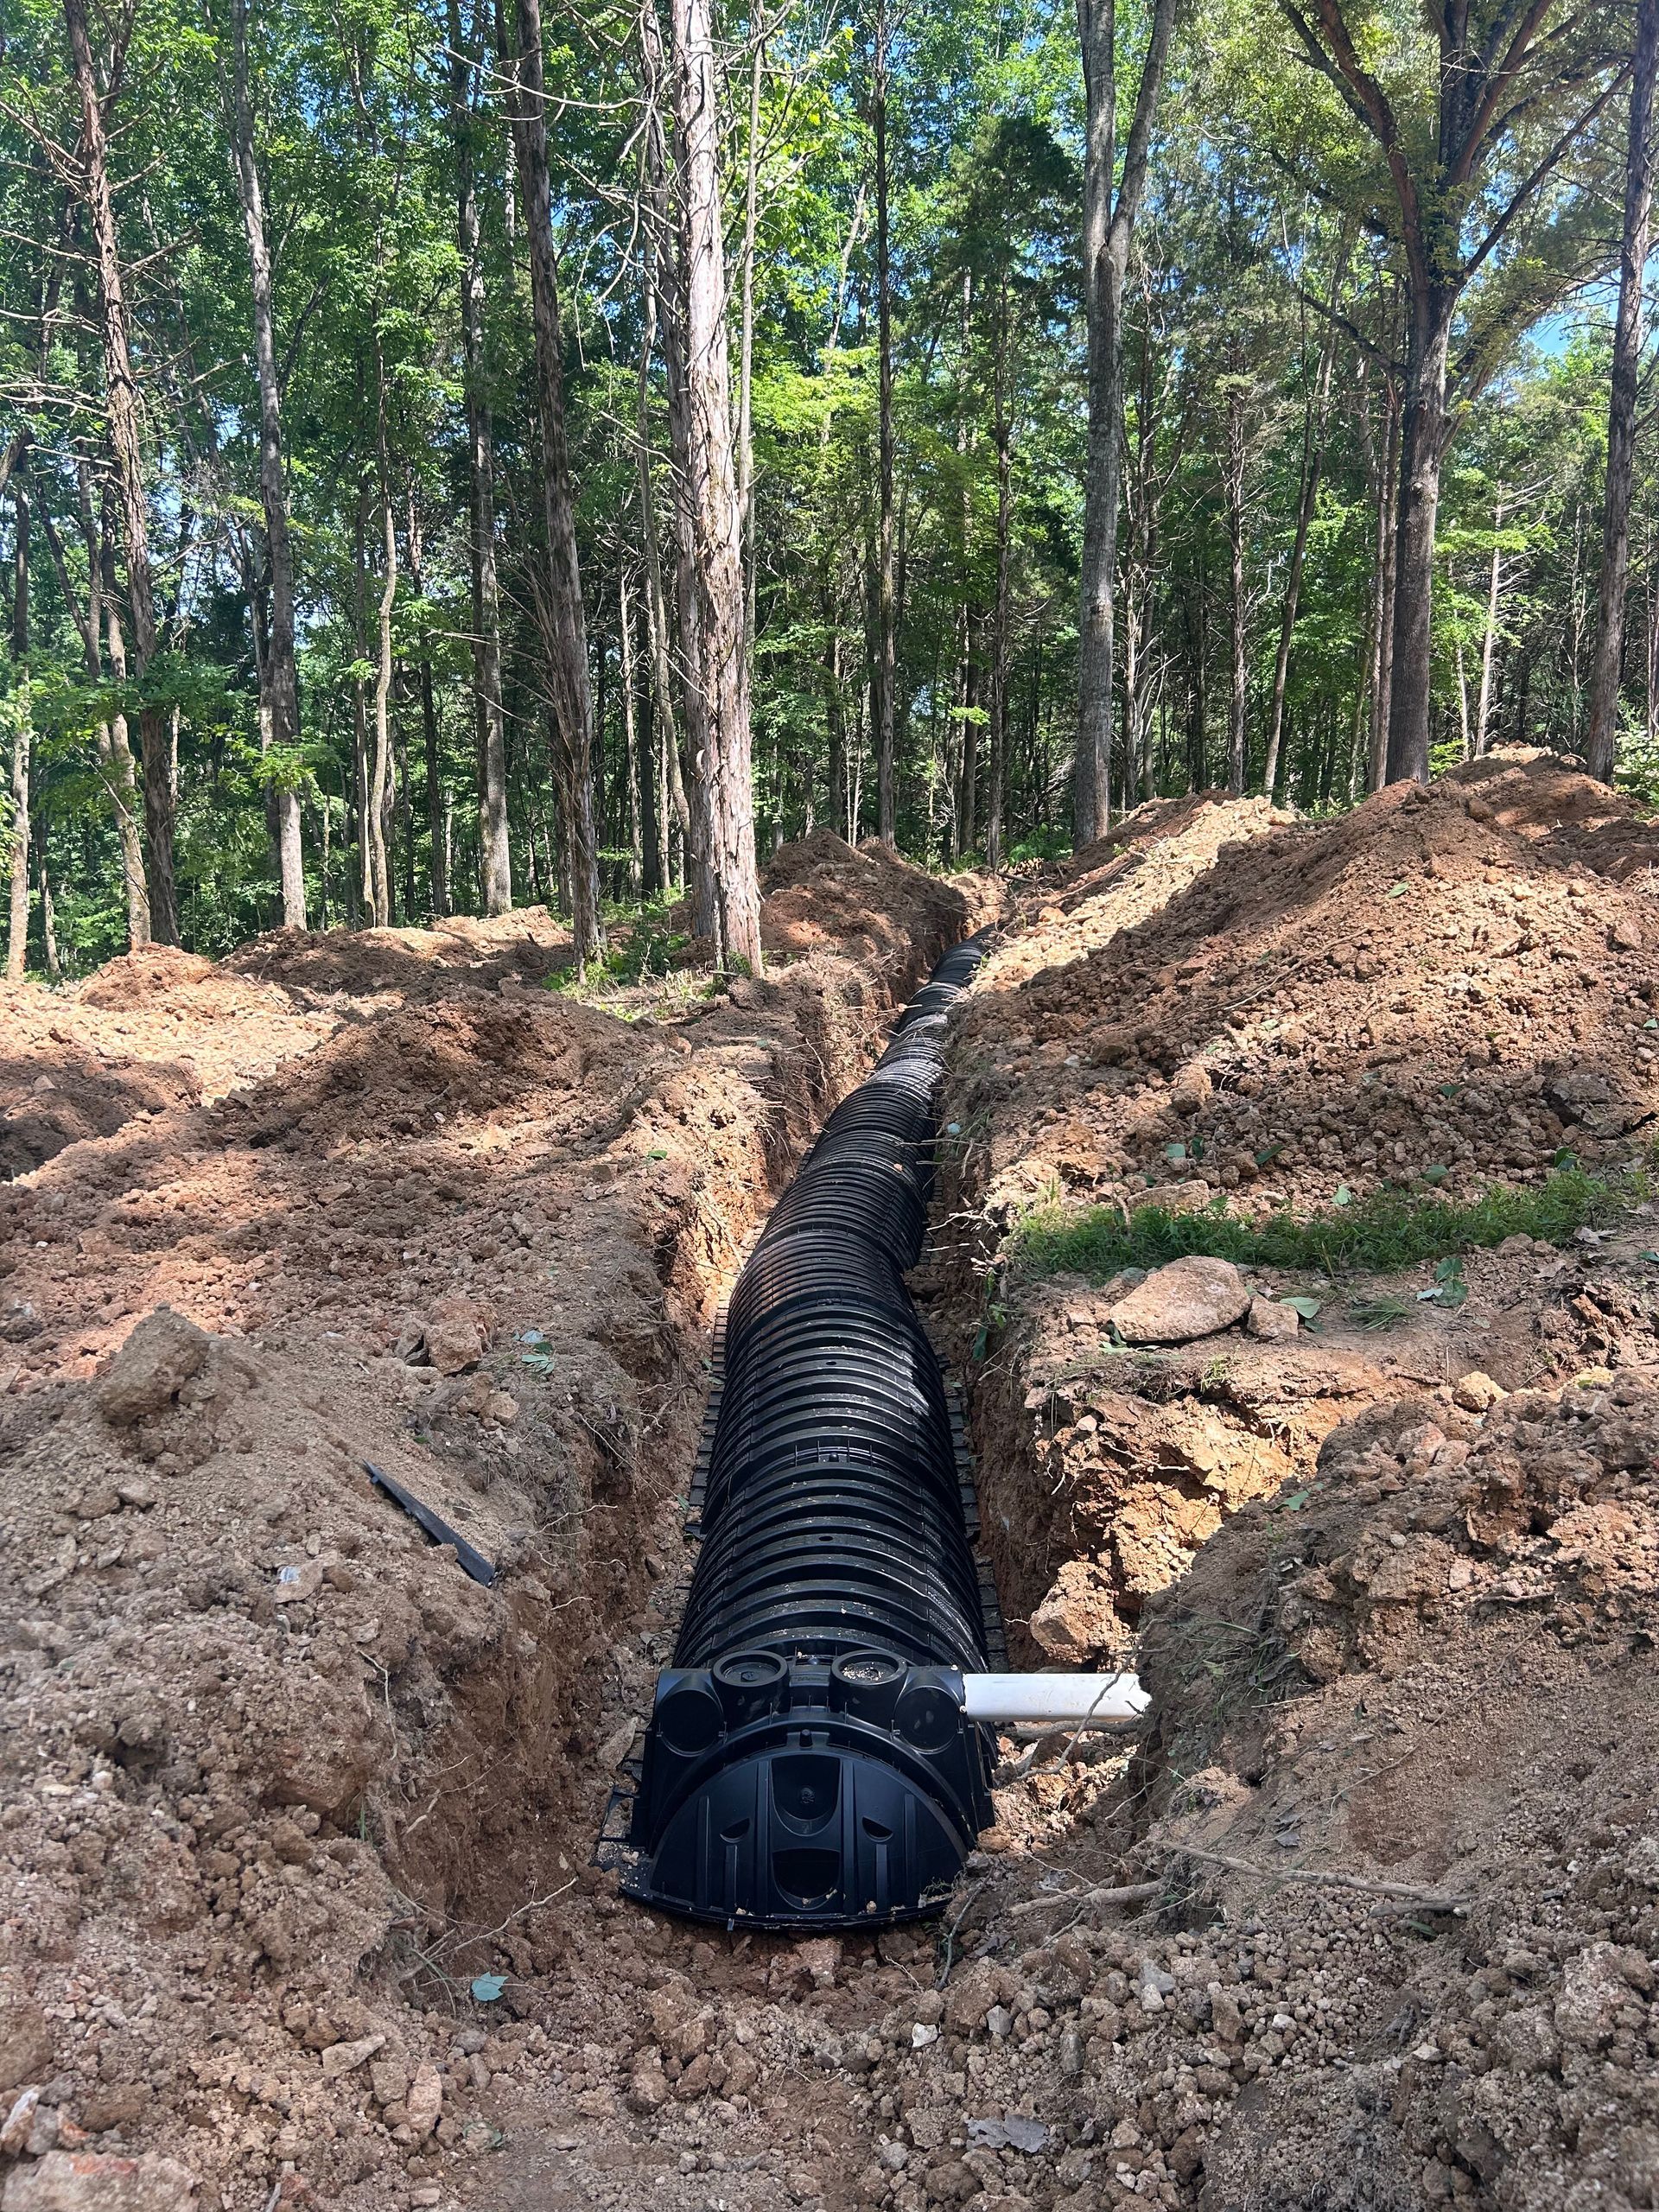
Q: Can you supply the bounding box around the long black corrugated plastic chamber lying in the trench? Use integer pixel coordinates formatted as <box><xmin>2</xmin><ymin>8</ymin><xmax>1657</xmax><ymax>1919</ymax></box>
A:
<box><xmin>624</xmin><ymin>940</ymin><xmax>991</xmax><ymax>1927</ymax></box>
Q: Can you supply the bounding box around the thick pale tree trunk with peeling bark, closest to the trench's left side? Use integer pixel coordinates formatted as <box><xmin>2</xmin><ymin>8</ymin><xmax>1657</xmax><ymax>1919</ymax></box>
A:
<box><xmin>672</xmin><ymin>0</ymin><xmax>763</xmax><ymax>976</ymax></box>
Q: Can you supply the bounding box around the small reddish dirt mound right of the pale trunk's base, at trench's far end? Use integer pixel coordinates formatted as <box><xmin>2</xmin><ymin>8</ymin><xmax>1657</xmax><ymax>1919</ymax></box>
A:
<box><xmin>761</xmin><ymin>830</ymin><xmax>995</xmax><ymax>973</ymax></box>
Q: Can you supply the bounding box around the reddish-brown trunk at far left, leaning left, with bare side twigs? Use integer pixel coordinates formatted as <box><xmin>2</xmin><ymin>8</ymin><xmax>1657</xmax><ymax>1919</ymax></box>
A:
<box><xmin>64</xmin><ymin>0</ymin><xmax>179</xmax><ymax>944</ymax></box>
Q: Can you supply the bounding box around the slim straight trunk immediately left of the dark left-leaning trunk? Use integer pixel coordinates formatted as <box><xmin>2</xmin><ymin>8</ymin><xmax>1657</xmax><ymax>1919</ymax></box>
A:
<box><xmin>449</xmin><ymin>0</ymin><xmax>513</xmax><ymax>913</ymax></box>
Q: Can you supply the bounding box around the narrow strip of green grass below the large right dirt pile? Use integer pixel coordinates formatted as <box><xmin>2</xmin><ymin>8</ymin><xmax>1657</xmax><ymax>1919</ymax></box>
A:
<box><xmin>1008</xmin><ymin>1166</ymin><xmax>1650</xmax><ymax>1283</ymax></box>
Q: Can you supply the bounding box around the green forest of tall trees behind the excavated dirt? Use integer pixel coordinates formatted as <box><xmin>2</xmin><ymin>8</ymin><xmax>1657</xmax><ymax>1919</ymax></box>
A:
<box><xmin>0</xmin><ymin>0</ymin><xmax>1659</xmax><ymax>980</ymax></box>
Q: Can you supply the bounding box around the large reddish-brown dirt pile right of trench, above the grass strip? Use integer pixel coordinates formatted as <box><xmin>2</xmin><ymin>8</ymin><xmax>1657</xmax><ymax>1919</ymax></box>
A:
<box><xmin>953</xmin><ymin>757</ymin><xmax>1659</xmax><ymax>1247</ymax></box>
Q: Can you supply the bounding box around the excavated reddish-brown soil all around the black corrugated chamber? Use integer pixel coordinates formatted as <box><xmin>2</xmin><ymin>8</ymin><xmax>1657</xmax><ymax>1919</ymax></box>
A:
<box><xmin>0</xmin><ymin>757</ymin><xmax>1659</xmax><ymax>2212</ymax></box>
